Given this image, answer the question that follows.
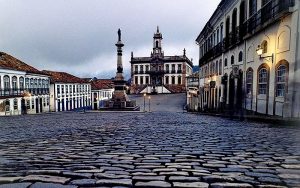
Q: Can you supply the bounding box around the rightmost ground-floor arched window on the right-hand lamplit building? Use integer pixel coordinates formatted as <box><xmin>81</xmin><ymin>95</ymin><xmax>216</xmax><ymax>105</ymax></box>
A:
<box><xmin>276</xmin><ymin>65</ymin><xmax>287</xmax><ymax>97</ymax></box>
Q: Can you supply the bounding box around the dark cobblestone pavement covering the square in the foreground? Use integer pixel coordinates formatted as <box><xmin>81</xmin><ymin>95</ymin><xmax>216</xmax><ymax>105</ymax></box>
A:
<box><xmin>0</xmin><ymin>112</ymin><xmax>300</xmax><ymax>188</ymax></box>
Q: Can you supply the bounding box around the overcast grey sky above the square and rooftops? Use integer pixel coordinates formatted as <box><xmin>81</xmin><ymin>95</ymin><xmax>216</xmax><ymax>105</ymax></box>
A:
<box><xmin>0</xmin><ymin>0</ymin><xmax>220</xmax><ymax>78</ymax></box>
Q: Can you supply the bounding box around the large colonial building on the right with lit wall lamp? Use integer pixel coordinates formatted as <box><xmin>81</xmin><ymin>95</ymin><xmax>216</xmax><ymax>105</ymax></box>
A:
<box><xmin>196</xmin><ymin>0</ymin><xmax>300</xmax><ymax>117</ymax></box>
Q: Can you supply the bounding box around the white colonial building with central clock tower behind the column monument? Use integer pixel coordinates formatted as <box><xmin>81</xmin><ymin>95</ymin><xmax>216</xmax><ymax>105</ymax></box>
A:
<box><xmin>130</xmin><ymin>28</ymin><xmax>193</xmax><ymax>93</ymax></box>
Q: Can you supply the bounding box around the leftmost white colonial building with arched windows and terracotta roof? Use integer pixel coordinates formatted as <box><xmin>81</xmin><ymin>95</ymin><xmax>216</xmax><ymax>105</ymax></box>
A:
<box><xmin>0</xmin><ymin>52</ymin><xmax>49</xmax><ymax>116</ymax></box>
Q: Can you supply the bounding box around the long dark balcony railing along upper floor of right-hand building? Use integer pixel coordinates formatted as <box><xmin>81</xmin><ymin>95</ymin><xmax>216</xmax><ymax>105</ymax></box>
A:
<box><xmin>199</xmin><ymin>0</ymin><xmax>295</xmax><ymax>66</ymax></box>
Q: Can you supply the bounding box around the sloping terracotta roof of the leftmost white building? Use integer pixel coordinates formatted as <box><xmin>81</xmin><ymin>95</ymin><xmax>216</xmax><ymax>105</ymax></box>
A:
<box><xmin>0</xmin><ymin>52</ymin><xmax>43</xmax><ymax>74</ymax></box>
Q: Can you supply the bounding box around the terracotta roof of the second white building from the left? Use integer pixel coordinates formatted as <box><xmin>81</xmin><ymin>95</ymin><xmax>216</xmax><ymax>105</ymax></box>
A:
<box><xmin>43</xmin><ymin>70</ymin><xmax>89</xmax><ymax>83</ymax></box>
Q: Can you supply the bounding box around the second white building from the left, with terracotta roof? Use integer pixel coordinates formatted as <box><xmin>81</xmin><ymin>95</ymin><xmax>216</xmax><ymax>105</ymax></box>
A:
<box><xmin>43</xmin><ymin>71</ymin><xmax>91</xmax><ymax>112</ymax></box>
